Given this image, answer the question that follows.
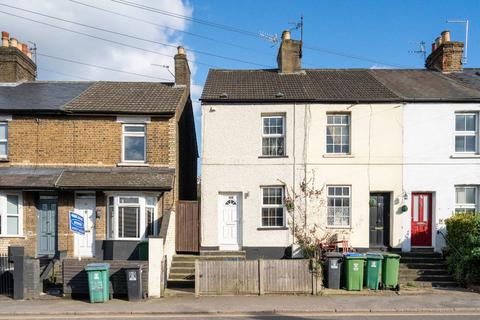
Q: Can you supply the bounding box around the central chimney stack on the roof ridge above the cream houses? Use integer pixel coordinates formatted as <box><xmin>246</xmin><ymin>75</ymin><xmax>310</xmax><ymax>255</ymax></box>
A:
<box><xmin>277</xmin><ymin>30</ymin><xmax>302</xmax><ymax>74</ymax></box>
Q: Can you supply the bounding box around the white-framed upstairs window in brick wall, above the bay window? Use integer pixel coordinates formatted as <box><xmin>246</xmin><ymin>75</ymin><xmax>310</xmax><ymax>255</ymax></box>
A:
<box><xmin>122</xmin><ymin>124</ymin><xmax>147</xmax><ymax>163</ymax></box>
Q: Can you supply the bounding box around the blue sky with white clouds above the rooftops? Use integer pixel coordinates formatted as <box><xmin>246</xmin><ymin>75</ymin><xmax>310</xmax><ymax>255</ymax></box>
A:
<box><xmin>0</xmin><ymin>0</ymin><xmax>480</xmax><ymax>175</ymax></box>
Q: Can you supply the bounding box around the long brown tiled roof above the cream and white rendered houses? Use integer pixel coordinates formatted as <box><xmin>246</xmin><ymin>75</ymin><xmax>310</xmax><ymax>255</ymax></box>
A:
<box><xmin>201</xmin><ymin>69</ymin><xmax>480</xmax><ymax>103</ymax></box>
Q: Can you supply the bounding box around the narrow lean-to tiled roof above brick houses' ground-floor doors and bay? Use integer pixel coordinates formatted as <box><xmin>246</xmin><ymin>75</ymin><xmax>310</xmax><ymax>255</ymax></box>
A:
<box><xmin>0</xmin><ymin>167</ymin><xmax>174</xmax><ymax>191</ymax></box>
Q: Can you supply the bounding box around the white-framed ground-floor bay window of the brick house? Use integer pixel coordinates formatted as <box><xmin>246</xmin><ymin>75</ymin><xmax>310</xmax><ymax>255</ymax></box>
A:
<box><xmin>107</xmin><ymin>194</ymin><xmax>158</xmax><ymax>239</ymax></box>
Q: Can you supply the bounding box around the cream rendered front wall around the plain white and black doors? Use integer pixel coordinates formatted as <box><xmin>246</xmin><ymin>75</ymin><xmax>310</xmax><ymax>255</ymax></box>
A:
<box><xmin>201</xmin><ymin>104</ymin><xmax>404</xmax><ymax>247</ymax></box>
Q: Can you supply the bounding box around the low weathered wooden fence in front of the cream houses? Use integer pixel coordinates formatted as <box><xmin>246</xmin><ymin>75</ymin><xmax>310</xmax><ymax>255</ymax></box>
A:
<box><xmin>195</xmin><ymin>260</ymin><xmax>321</xmax><ymax>296</ymax></box>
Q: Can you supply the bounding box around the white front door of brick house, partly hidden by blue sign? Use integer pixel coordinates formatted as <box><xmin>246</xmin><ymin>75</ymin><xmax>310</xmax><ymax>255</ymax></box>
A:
<box><xmin>74</xmin><ymin>192</ymin><xmax>96</xmax><ymax>258</ymax></box>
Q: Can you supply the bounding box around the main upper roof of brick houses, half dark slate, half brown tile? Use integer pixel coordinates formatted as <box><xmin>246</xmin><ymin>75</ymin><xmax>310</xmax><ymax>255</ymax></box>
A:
<box><xmin>0</xmin><ymin>81</ymin><xmax>186</xmax><ymax>114</ymax></box>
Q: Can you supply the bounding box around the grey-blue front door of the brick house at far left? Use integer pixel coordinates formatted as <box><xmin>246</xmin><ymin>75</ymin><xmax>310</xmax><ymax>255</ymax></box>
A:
<box><xmin>37</xmin><ymin>197</ymin><xmax>57</xmax><ymax>256</ymax></box>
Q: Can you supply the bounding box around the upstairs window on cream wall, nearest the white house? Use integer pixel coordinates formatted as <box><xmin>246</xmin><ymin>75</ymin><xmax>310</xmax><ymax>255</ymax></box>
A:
<box><xmin>327</xmin><ymin>114</ymin><xmax>350</xmax><ymax>154</ymax></box>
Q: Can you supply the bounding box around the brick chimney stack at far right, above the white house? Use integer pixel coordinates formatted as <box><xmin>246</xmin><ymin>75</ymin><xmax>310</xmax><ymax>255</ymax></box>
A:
<box><xmin>425</xmin><ymin>30</ymin><xmax>464</xmax><ymax>73</ymax></box>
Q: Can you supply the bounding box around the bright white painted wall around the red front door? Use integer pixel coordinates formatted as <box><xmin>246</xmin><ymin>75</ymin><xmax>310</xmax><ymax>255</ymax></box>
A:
<box><xmin>402</xmin><ymin>103</ymin><xmax>480</xmax><ymax>251</ymax></box>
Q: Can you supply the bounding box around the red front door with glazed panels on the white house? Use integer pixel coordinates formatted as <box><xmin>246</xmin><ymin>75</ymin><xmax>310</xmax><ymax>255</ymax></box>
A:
<box><xmin>410</xmin><ymin>193</ymin><xmax>432</xmax><ymax>247</ymax></box>
